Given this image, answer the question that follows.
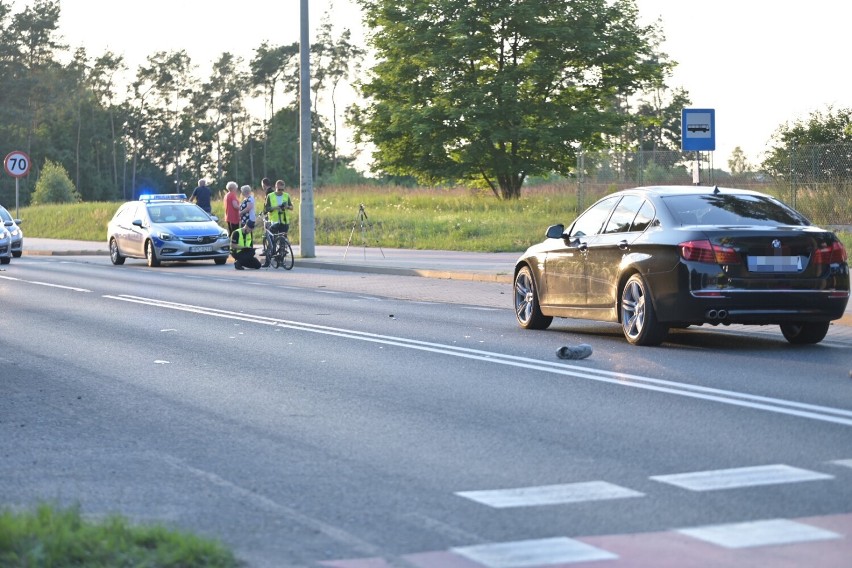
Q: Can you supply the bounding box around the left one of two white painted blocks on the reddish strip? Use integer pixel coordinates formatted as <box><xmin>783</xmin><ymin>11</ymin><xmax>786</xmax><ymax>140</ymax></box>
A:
<box><xmin>450</xmin><ymin>537</ymin><xmax>618</xmax><ymax>568</ymax></box>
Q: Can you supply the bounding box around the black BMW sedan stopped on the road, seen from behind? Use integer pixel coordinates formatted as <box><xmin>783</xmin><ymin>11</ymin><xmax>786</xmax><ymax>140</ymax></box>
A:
<box><xmin>514</xmin><ymin>186</ymin><xmax>849</xmax><ymax>345</ymax></box>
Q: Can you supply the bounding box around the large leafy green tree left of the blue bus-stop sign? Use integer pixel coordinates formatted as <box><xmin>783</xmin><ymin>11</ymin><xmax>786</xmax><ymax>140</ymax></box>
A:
<box><xmin>350</xmin><ymin>0</ymin><xmax>665</xmax><ymax>199</ymax></box>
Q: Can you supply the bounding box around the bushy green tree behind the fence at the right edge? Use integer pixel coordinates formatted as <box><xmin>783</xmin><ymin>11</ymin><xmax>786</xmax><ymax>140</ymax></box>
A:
<box><xmin>763</xmin><ymin>106</ymin><xmax>852</xmax><ymax>182</ymax></box>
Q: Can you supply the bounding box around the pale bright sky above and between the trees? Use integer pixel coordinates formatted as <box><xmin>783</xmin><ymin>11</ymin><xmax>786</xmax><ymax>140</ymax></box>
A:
<box><xmin>50</xmin><ymin>0</ymin><xmax>852</xmax><ymax>173</ymax></box>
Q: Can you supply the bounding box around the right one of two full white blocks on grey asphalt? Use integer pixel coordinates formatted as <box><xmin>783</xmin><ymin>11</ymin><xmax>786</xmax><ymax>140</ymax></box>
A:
<box><xmin>650</xmin><ymin>464</ymin><xmax>834</xmax><ymax>491</ymax></box>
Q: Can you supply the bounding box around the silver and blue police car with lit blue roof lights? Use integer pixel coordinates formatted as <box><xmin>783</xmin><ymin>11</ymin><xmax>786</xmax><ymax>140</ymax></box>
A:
<box><xmin>107</xmin><ymin>193</ymin><xmax>230</xmax><ymax>266</ymax></box>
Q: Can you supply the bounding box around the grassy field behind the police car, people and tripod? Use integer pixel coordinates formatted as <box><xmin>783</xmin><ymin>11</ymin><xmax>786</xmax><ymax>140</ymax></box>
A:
<box><xmin>11</xmin><ymin>185</ymin><xmax>852</xmax><ymax>252</ymax></box>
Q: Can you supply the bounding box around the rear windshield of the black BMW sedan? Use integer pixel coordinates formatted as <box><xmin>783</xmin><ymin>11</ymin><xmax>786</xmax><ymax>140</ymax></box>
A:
<box><xmin>663</xmin><ymin>193</ymin><xmax>810</xmax><ymax>226</ymax></box>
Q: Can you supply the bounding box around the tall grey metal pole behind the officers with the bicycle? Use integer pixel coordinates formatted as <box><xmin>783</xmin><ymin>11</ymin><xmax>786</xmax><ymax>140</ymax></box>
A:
<box><xmin>299</xmin><ymin>0</ymin><xmax>316</xmax><ymax>258</ymax></box>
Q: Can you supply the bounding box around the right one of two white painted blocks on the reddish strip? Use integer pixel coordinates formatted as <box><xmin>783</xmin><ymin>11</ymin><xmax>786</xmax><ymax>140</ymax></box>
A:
<box><xmin>675</xmin><ymin>519</ymin><xmax>842</xmax><ymax>548</ymax></box>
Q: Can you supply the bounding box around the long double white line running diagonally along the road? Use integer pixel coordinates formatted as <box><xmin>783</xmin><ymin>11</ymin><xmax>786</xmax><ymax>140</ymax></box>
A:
<box><xmin>103</xmin><ymin>294</ymin><xmax>852</xmax><ymax>426</ymax></box>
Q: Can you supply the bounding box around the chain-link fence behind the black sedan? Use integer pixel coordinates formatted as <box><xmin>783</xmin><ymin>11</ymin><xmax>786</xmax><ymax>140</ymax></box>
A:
<box><xmin>570</xmin><ymin>144</ymin><xmax>852</xmax><ymax>227</ymax></box>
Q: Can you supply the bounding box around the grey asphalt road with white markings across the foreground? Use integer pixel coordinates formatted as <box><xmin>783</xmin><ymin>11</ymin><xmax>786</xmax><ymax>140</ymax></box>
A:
<box><xmin>0</xmin><ymin>257</ymin><xmax>852</xmax><ymax>568</ymax></box>
